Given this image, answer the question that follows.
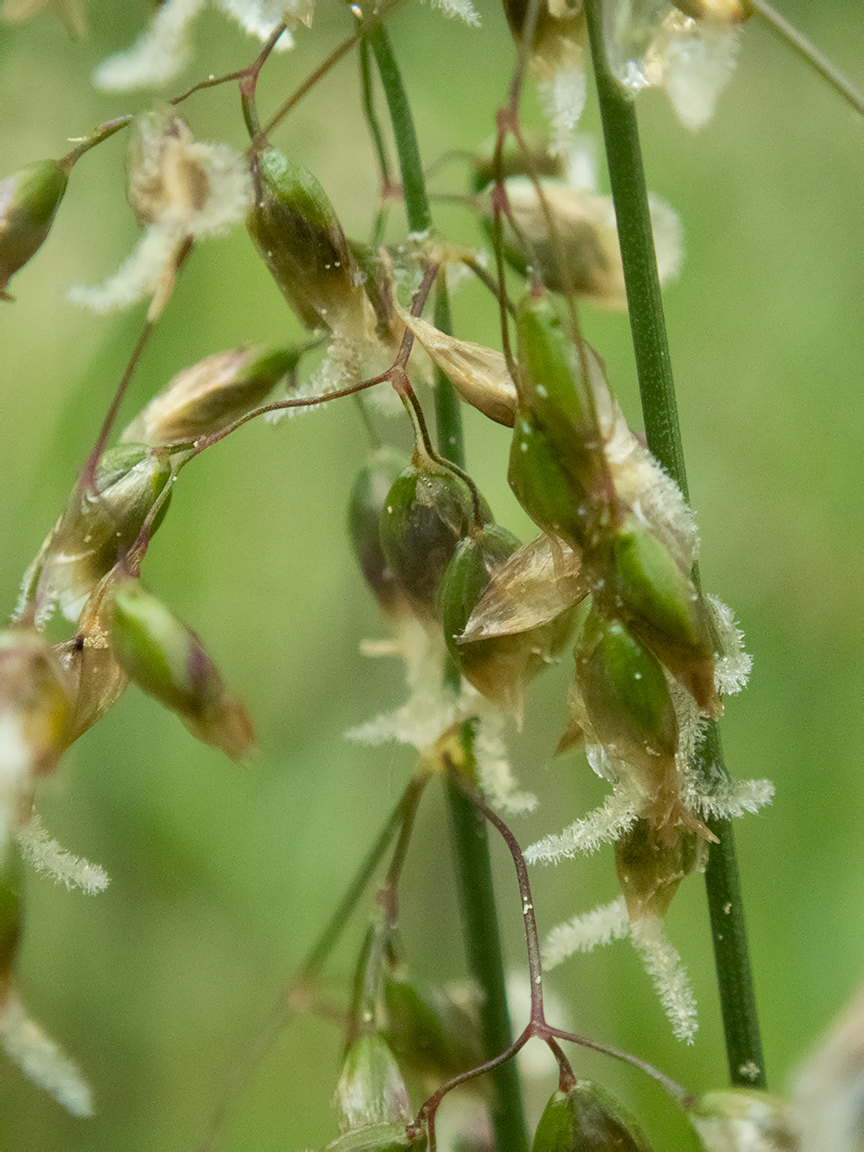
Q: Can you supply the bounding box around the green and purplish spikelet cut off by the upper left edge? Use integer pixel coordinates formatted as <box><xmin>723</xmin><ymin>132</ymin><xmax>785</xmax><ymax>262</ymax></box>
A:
<box><xmin>0</xmin><ymin>160</ymin><xmax>70</xmax><ymax>300</ymax></box>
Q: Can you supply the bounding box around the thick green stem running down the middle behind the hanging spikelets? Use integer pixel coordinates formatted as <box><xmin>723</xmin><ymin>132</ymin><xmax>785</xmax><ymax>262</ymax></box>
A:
<box><xmin>365</xmin><ymin>24</ymin><xmax>528</xmax><ymax>1152</ymax></box>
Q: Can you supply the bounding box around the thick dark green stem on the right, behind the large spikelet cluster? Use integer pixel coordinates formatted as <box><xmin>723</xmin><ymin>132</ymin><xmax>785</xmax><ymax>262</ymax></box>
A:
<box><xmin>585</xmin><ymin>0</ymin><xmax>765</xmax><ymax>1087</ymax></box>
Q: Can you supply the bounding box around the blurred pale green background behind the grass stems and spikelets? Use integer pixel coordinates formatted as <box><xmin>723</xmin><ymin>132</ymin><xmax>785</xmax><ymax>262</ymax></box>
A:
<box><xmin>0</xmin><ymin>0</ymin><xmax>864</xmax><ymax>1152</ymax></box>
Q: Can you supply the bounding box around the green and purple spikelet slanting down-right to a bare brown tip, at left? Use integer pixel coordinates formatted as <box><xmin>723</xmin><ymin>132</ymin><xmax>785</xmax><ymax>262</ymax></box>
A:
<box><xmin>108</xmin><ymin>579</ymin><xmax>255</xmax><ymax>760</ymax></box>
